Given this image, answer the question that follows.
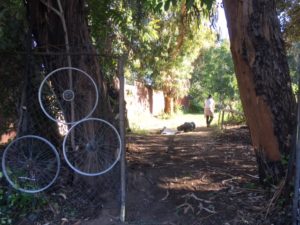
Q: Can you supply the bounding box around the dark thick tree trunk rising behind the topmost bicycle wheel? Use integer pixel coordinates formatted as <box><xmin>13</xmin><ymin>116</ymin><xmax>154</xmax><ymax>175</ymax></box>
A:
<box><xmin>26</xmin><ymin>0</ymin><xmax>113</xmax><ymax>120</ymax></box>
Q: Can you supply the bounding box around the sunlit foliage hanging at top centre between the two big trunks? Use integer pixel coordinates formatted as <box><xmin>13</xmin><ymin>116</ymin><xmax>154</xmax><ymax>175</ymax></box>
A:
<box><xmin>87</xmin><ymin>0</ymin><xmax>218</xmax><ymax>102</ymax></box>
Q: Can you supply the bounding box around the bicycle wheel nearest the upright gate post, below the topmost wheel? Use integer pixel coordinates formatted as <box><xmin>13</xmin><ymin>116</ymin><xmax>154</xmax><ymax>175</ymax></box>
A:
<box><xmin>63</xmin><ymin>118</ymin><xmax>121</xmax><ymax>176</ymax></box>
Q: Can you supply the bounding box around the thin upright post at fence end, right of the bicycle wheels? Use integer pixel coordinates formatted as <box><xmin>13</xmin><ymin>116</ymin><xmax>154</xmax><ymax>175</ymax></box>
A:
<box><xmin>118</xmin><ymin>56</ymin><xmax>126</xmax><ymax>222</ymax></box>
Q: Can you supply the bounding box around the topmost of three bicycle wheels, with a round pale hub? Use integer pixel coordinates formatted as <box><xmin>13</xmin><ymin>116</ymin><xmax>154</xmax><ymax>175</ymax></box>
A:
<box><xmin>38</xmin><ymin>67</ymin><xmax>98</xmax><ymax>124</ymax></box>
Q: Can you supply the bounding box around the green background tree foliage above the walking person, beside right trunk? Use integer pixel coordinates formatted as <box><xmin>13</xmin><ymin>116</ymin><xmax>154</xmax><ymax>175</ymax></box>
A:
<box><xmin>189</xmin><ymin>41</ymin><xmax>239</xmax><ymax>112</ymax></box>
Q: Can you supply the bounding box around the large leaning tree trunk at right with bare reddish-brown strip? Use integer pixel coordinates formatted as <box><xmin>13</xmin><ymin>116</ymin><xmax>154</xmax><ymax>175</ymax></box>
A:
<box><xmin>223</xmin><ymin>0</ymin><xmax>296</xmax><ymax>183</ymax></box>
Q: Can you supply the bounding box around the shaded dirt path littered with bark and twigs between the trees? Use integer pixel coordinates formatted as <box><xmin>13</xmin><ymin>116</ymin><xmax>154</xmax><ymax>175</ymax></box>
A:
<box><xmin>85</xmin><ymin>128</ymin><xmax>286</xmax><ymax>225</ymax></box>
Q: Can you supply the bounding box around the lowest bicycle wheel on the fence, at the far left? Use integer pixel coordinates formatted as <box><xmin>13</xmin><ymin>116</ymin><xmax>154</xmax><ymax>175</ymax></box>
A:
<box><xmin>2</xmin><ymin>135</ymin><xmax>60</xmax><ymax>193</ymax></box>
